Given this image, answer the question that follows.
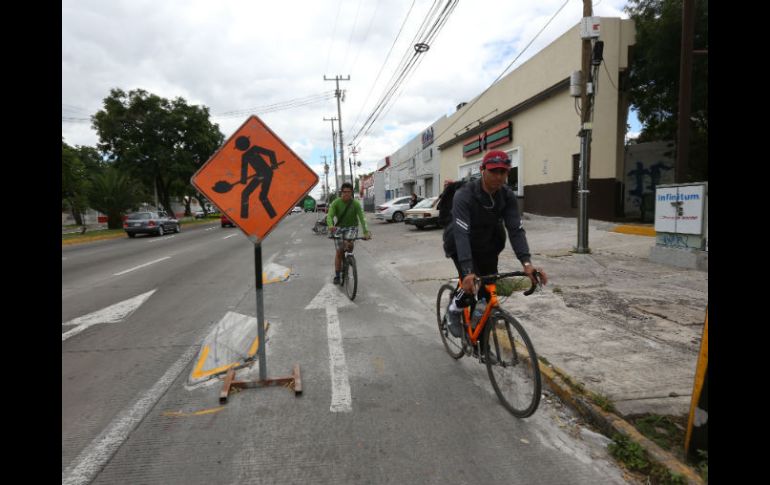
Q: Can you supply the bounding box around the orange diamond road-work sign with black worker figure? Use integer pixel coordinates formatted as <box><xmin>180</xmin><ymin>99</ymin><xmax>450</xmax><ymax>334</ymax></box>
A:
<box><xmin>190</xmin><ymin>116</ymin><xmax>318</xmax><ymax>240</ymax></box>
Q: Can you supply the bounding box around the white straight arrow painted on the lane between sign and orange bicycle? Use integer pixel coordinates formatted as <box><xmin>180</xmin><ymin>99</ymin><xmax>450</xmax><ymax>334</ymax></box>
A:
<box><xmin>305</xmin><ymin>283</ymin><xmax>356</xmax><ymax>413</ymax></box>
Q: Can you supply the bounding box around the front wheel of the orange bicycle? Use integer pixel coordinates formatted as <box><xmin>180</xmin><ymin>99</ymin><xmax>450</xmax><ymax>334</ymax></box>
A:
<box><xmin>482</xmin><ymin>310</ymin><xmax>541</xmax><ymax>418</ymax></box>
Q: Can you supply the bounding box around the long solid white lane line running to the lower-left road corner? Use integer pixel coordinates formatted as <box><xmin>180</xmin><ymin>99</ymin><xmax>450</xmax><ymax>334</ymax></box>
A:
<box><xmin>62</xmin><ymin>346</ymin><xmax>198</xmax><ymax>485</ymax></box>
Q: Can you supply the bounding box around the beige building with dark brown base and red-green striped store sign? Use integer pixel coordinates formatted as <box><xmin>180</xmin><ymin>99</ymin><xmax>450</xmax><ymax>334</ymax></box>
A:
<box><xmin>434</xmin><ymin>18</ymin><xmax>635</xmax><ymax>220</ymax></box>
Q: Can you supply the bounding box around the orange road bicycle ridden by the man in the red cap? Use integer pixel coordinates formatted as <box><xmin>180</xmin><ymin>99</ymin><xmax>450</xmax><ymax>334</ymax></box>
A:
<box><xmin>436</xmin><ymin>271</ymin><xmax>542</xmax><ymax>418</ymax></box>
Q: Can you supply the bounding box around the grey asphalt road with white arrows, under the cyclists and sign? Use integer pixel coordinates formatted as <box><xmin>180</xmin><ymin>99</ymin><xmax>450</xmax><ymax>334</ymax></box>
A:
<box><xmin>62</xmin><ymin>213</ymin><xmax>626</xmax><ymax>484</ymax></box>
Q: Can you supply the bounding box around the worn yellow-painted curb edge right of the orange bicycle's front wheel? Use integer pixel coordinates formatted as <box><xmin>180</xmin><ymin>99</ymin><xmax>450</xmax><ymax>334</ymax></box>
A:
<box><xmin>539</xmin><ymin>362</ymin><xmax>704</xmax><ymax>485</ymax></box>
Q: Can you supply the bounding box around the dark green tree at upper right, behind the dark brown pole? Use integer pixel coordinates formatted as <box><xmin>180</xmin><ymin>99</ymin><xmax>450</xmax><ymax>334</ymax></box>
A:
<box><xmin>626</xmin><ymin>0</ymin><xmax>708</xmax><ymax>181</ymax></box>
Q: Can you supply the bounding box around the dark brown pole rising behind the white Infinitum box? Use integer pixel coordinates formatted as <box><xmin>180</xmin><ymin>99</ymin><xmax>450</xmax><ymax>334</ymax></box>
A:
<box><xmin>674</xmin><ymin>0</ymin><xmax>695</xmax><ymax>184</ymax></box>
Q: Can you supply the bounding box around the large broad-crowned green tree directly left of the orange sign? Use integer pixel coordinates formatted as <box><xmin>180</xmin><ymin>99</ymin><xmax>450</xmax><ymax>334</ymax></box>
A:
<box><xmin>92</xmin><ymin>89</ymin><xmax>224</xmax><ymax>214</ymax></box>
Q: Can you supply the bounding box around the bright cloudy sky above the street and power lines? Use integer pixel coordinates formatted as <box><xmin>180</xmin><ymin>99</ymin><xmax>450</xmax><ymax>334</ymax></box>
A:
<box><xmin>62</xmin><ymin>0</ymin><xmax>639</xmax><ymax>199</ymax></box>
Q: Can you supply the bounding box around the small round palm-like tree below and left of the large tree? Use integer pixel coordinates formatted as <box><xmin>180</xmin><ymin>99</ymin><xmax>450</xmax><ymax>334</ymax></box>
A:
<box><xmin>88</xmin><ymin>167</ymin><xmax>146</xmax><ymax>229</ymax></box>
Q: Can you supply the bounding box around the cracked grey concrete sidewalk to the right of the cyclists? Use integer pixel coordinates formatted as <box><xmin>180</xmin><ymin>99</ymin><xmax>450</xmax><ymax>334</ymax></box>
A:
<box><xmin>371</xmin><ymin>214</ymin><xmax>708</xmax><ymax>483</ymax></box>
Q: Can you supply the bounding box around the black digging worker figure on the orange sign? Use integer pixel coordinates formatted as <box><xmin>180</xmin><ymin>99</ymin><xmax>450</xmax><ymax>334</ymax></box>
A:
<box><xmin>212</xmin><ymin>136</ymin><xmax>285</xmax><ymax>219</ymax></box>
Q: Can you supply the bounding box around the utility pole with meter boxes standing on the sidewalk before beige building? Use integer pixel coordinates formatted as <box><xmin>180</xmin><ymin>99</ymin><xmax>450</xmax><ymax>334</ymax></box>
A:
<box><xmin>575</xmin><ymin>0</ymin><xmax>593</xmax><ymax>253</ymax></box>
